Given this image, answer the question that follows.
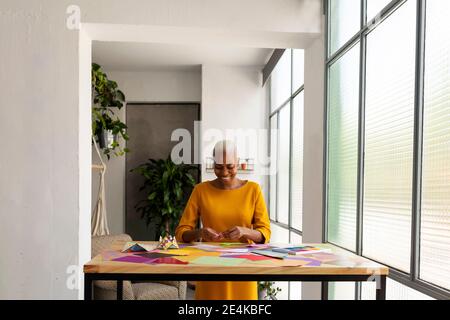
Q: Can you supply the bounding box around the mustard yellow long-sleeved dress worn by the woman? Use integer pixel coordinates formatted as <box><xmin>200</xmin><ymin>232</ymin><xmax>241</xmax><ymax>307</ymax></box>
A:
<box><xmin>175</xmin><ymin>181</ymin><xmax>270</xmax><ymax>300</ymax></box>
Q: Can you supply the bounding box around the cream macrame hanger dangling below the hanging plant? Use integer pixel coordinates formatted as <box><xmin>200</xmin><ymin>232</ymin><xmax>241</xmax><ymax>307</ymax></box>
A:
<box><xmin>91</xmin><ymin>137</ymin><xmax>109</xmax><ymax>236</ymax></box>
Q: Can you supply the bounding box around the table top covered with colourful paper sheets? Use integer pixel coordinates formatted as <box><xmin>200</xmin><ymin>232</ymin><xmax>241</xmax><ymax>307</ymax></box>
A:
<box><xmin>84</xmin><ymin>241</ymin><xmax>389</xmax><ymax>275</ymax></box>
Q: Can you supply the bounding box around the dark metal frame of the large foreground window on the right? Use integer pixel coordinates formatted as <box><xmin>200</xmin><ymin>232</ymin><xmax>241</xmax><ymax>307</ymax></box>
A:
<box><xmin>322</xmin><ymin>0</ymin><xmax>450</xmax><ymax>300</ymax></box>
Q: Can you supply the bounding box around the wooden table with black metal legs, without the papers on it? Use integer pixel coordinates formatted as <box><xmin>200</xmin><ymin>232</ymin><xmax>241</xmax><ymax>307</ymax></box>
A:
<box><xmin>84</xmin><ymin>241</ymin><xmax>389</xmax><ymax>300</ymax></box>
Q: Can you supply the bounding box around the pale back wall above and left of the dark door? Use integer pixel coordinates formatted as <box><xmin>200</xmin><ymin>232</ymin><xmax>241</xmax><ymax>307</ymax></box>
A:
<box><xmin>91</xmin><ymin>68</ymin><xmax>201</xmax><ymax>234</ymax></box>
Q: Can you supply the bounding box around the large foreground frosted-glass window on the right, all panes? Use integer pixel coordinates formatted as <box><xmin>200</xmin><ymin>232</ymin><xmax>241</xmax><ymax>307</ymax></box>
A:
<box><xmin>325</xmin><ymin>0</ymin><xmax>450</xmax><ymax>299</ymax></box>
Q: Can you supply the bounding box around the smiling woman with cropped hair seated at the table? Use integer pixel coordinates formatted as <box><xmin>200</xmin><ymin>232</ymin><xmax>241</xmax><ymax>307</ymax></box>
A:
<box><xmin>175</xmin><ymin>141</ymin><xmax>270</xmax><ymax>300</ymax></box>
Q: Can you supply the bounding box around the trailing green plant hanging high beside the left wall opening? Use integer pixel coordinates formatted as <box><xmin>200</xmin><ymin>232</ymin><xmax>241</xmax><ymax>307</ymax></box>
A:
<box><xmin>92</xmin><ymin>63</ymin><xmax>129</xmax><ymax>159</ymax></box>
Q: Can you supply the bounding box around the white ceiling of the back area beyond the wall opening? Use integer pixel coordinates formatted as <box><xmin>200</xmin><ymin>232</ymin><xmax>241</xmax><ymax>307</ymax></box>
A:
<box><xmin>92</xmin><ymin>41</ymin><xmax>273</xmax><ymax>71</ymax></box>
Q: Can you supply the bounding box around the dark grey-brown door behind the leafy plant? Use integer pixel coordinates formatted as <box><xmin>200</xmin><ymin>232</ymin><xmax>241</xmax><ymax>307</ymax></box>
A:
<box><xmin>125</xmin><ymin>103</ymin><xmax>200</xmax><ymax>240</ymax></box>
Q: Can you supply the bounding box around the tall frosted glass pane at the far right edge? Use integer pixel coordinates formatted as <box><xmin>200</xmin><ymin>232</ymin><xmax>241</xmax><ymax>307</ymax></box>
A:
<box><xmin>420</xmin><ymin>0</ymin><xmax>450</xmax><ymax>289</ymax></box>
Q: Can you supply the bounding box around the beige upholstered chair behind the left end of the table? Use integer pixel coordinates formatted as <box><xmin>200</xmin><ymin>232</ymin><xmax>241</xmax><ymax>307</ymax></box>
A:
<box><xmin>92</xmin><ymin>234</ymin><xmax>186</xmax><ymax>300</ymax></box>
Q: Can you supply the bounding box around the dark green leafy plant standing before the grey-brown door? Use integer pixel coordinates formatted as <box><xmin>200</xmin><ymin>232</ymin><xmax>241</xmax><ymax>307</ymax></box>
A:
<box><xmin>131</xmin><ymin>156</ymin><xmax>198</xmax><ymax>240</ymax></box>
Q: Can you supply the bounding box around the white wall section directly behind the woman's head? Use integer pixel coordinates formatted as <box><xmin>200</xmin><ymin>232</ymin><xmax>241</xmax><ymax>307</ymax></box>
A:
<box><xmin>201</xmin><ymin>65</ymin><xmax>268</xmax><ymax>199</ymax></box>
